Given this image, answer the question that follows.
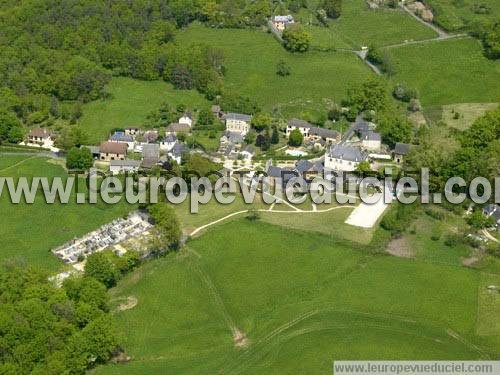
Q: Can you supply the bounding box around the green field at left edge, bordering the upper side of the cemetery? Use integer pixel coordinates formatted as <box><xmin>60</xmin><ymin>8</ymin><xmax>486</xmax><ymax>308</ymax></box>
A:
<box><xmin>0</xmin><ymin>155</ymin><xmax>133</xmax><ymax>271</ymax></box>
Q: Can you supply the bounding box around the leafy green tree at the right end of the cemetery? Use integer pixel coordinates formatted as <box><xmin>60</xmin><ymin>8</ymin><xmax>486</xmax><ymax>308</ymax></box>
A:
<box><xmin>149</xmin><ymin>202</ymin><xmax>182</xmax><ymax>253</ymax></box>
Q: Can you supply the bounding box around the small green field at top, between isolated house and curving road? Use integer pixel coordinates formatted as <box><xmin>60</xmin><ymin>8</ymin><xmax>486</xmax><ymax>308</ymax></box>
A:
<box><xmin>330</xmin><ymin>0</ymin><xmax>437</xmax><ymax>49</ymax></box>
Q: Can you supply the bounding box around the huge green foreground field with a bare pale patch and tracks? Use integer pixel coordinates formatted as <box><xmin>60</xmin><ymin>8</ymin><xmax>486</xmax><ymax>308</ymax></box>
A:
<box><xmin>96</xmin><ymin>219</ymin><xmax>500</xmax><ymax>374</ymax></box>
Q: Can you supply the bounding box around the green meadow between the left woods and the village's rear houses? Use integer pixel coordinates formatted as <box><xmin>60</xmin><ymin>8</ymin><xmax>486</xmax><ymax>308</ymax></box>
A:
<box><xmin>79</xmin><ymin>77</ymin><xmax>209</xmax><ymax>143</ymax></box>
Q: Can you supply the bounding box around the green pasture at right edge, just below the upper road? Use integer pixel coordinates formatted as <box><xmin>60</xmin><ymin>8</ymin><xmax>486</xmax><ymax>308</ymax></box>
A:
<box><xmin>388</xmin><ymin>38</ymin><xmax>500</xmax><ymax>106</ymax></box>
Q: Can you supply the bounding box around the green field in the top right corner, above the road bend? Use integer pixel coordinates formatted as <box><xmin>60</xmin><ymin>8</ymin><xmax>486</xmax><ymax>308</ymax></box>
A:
<box><xmin>426</xmin><ymin>0</ymin><xmax>500</xmax><ymax>31</ymax></box>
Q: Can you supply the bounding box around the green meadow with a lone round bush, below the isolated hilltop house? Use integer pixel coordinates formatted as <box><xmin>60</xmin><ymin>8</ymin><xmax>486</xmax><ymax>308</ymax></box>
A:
<box><xmin>177</xmin><ymin>23</ymin><xmax>372</xmax><ymax>116</ymax></box>
